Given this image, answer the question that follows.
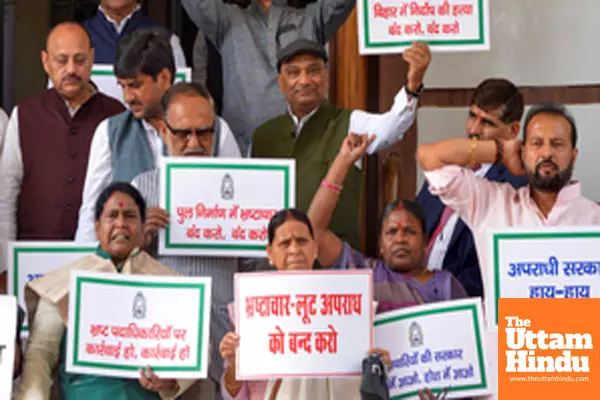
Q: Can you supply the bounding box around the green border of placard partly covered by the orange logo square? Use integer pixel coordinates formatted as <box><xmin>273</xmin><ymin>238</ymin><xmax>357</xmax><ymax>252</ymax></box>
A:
<box><xmin>492</xmin><ymin>232</ymin><xmax>600</xmax><ymax>326</ymax></box>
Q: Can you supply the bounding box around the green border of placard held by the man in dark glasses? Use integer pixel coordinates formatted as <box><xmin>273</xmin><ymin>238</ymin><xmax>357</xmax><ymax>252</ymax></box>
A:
<box><xmin>165</xmin><ymin>163</ymin><xmax>290</xmax><ymax>251</ymax></box>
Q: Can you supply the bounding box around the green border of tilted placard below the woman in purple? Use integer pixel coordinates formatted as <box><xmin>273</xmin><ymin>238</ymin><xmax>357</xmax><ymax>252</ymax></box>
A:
<box><xmin>373</xmin><ymin>304</ymin><xmax>487</xmax><ymax>400</ymax></box>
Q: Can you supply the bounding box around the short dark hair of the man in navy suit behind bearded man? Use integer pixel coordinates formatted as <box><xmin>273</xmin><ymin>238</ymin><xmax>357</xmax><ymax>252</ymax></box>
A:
<box><xmin>471</xmin><ymin>78</ymin><xmax>525</xmax><ymax>124</ymax></box>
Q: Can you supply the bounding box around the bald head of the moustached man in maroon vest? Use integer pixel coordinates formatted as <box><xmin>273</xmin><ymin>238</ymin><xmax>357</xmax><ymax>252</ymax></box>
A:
<box><xmin>42</xmin><ymin>22</ymin><xmax>94</xmax><ymax>101</ymax></box>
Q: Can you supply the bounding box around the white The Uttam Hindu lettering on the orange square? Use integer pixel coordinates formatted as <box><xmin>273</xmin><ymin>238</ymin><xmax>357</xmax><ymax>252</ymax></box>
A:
<box><xmin>504</xmin><ymin>316</ymin><xmax>594</xmax><ymax>373</ymax></box>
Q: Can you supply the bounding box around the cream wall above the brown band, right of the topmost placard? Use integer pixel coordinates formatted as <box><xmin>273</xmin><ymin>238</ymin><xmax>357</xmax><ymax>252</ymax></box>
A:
<box><xmin>425</xmin><ymin>0</ymin><xmax>600</xmax><ymax>88</ymax></box>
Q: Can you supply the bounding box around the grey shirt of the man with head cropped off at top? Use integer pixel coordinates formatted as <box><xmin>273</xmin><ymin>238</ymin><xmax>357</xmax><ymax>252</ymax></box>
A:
<box><xmin>182</xmin><ymin>0</ymin><xmax>356</xmax><ymax>154</ymax></box>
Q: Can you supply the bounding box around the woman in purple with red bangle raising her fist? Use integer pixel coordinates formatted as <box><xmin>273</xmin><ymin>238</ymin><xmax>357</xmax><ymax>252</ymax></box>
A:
<box><xmin>308</xmin><ymin>134</ymin><xmax>466</xmax><ymax>311</ymax></box>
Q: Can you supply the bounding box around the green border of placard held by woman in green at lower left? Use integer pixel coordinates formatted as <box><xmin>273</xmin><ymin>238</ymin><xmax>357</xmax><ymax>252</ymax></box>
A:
<box><xmin>73</xmin><ymin>276</ymin><xmax>206</xmax><ymax>372</ymax></box>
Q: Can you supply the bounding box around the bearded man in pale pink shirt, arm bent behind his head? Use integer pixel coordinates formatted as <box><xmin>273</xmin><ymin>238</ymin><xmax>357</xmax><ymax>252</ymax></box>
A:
<box><xmin>417</xmin><ymin>103</ymin><xmax>600</xmax><ymax>400</ymax></box>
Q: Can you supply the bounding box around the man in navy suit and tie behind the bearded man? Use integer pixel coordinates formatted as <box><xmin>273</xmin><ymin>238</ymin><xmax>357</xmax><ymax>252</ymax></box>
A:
<box><xmin>417</xmin><ymin>79</ymin><xmax>527</xmax><ymax>296</ymax></box>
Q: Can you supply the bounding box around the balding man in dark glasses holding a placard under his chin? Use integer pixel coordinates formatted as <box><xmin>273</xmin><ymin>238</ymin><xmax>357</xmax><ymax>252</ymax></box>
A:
<box><xmin>132</xmin><ymin>82</ymin><xmax>243</xmax><ymax>392</ymax></box>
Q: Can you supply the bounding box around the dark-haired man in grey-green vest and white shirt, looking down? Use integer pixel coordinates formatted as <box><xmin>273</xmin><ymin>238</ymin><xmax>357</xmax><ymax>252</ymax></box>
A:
<box><xmin>75</xmin><ymin>28</ymin><xmax>240</xmax><ymax>243</ymax></box>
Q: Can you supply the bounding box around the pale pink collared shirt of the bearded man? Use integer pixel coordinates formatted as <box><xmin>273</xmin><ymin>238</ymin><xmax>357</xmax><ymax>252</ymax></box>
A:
<box><xmin>425</xmin><ymin>165</ymin><xmax>600</xmax><ymax>398</ymax></box>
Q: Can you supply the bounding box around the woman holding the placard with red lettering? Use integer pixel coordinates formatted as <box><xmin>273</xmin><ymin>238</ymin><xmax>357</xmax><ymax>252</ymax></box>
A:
<box><xmin>220</xmin><ymin>209</ymin><xmax>391</xmax><ymax>400</ymax></box>
